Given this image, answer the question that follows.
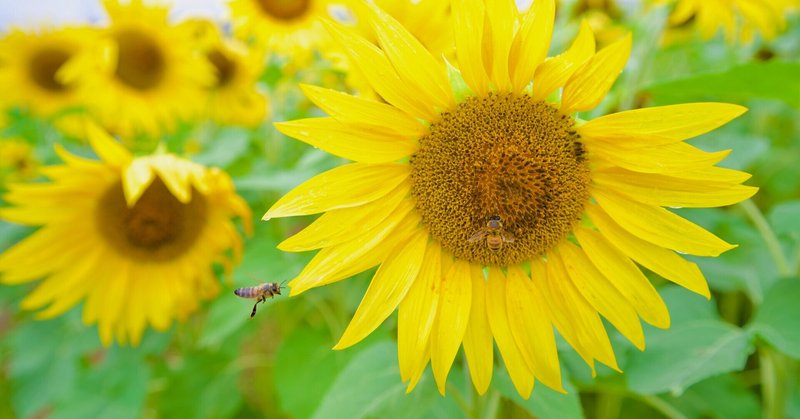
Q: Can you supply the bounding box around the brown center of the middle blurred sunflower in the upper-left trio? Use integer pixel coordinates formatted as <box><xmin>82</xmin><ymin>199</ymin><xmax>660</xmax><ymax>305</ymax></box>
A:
<box><xmin>115</xmin><ymin>29</ymin><xmax>167</xmax><ymax>90</ymax></box>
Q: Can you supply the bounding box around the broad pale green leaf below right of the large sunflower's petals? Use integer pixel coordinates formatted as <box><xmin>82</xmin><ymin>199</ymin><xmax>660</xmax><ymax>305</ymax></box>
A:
<box><xmin>625</xmin><ymin>319</ymin><xmax>753</xmax><ymax>394</ymax></box>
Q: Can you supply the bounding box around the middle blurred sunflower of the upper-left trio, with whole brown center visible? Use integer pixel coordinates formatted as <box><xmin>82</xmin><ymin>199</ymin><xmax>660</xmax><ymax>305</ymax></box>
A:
<box><xmin>64</xmin><ymin>0</ymin><xmax>214</xmax><ymax>137</ymax></box>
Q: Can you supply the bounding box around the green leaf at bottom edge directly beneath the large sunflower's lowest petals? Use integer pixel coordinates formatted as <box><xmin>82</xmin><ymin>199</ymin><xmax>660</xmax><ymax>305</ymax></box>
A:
<box><xmin>491</xmin><ymin>368</ymin><xmax>583</xmax><ymax>419</ymax></box>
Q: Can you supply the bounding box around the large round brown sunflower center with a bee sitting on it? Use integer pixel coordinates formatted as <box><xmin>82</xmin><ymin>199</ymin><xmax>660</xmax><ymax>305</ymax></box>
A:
<box><xmin>411</xmin><ymin>94</ymin><xmax>589</xmax><ymax>266</ymax></box>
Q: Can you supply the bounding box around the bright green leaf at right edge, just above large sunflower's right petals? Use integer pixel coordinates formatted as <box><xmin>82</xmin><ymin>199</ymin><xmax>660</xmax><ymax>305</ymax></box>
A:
<box><xmin>645</xmin><ymin>61</ymin><xmax>800</xmax><ymax>108</ymax></box>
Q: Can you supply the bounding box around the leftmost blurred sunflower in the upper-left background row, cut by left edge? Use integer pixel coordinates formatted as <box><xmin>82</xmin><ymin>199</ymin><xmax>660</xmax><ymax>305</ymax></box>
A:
<box><xmin>0</xmin><ymin>28</ymin><xmax>91</xmax><ymax>118</ymax></box>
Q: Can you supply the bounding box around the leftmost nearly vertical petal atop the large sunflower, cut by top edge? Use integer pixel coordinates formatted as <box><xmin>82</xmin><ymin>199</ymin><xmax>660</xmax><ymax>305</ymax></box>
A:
<box><xmin>451</xmin><ymin>0</ymin><xmax>489</xmax><ymax>97</ymax></box>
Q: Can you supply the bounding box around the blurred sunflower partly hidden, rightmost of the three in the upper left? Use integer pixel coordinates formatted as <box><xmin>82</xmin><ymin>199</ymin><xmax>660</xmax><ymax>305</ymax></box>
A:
<box><xmin>184</xmin><ymin>19</ymin><xmax>267</xmax><ymax>126</ymax></box>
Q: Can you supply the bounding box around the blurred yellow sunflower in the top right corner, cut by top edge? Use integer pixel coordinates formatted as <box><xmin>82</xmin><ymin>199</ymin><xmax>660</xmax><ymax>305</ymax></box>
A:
<box><xmin>656</xmin><ymin>0</ymin><xmax>797</xmax><ymax>42</ymax></box>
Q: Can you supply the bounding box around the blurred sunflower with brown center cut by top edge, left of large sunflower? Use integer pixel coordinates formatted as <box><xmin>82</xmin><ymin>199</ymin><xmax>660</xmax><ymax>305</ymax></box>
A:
<box><xmin>229</xmin><ymin>0</ymin><xmax>337</xmax><ymax>61</ymax></box>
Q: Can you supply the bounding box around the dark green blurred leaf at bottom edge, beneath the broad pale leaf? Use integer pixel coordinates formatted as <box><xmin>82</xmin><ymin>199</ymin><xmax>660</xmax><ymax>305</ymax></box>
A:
<box><xmin>664</xmin><ymin>374</ymin><xmax>761</xmax><ymax>419</ymax></box>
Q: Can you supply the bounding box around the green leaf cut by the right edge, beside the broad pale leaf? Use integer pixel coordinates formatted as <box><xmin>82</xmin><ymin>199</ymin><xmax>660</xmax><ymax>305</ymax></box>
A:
<box><xmin>749</xmin><ymin>278</ymin><xmax>800</xmax><ymax>358</ymax></box>
